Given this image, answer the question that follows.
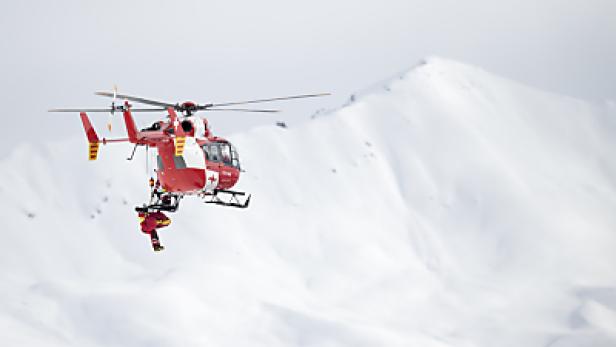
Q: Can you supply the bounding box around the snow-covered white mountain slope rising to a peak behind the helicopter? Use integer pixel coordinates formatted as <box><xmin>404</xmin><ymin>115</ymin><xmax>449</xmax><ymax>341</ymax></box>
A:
<box><xmin>0</xmin><ymin>58</ymin><xmax>616</xmax><ymax>347</ymax></box>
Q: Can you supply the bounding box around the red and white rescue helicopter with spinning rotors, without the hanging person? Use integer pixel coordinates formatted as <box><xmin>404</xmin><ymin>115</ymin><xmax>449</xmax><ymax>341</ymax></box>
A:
<box><xmin>49</xmin><ymin>88</ymin><xmax>329</xmax><ymax>213</ymax></box>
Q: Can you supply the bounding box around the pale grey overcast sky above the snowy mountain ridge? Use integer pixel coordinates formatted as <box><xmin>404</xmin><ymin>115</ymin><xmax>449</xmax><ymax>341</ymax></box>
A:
<box><xmin>0</xmin><ymin>0</ymin><xmax>616</xmax><ymax>157</ymax></box>
